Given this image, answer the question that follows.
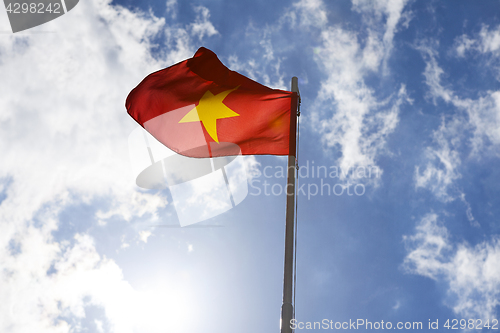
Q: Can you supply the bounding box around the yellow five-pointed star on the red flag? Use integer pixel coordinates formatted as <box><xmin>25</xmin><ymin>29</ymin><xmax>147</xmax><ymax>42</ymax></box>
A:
<box><xmin>179</xmin><ymin>87</ymin><xmax>239</xmax><ymax>143</ymax></box>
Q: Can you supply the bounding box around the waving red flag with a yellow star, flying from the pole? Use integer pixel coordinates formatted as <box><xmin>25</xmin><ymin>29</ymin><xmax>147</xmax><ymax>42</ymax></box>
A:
<box><xmin>126</xmin><ymin>47</ymin><xmax>297</xmax><ymax>157</ymax></box>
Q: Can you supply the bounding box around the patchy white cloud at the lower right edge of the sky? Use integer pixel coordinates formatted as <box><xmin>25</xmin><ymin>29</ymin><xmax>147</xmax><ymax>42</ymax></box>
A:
<box><xmin>402</xmin><ymin>213</ymin><xmax>500</xmax><ymax>320</ymax></box>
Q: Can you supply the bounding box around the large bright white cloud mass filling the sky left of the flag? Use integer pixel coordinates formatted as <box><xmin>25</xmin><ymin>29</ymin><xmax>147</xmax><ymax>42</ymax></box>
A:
<box><xmin>0</xmin><ymin>0</ymin><xmax>221</xmax><ymax>333</ymax></box>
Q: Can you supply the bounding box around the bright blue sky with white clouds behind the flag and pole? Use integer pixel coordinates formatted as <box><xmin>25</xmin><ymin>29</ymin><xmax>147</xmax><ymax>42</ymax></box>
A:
<box><xmin>0</xmin><ymin>0</ymin><xmax>500</xmax><ymax>333</ymax></box>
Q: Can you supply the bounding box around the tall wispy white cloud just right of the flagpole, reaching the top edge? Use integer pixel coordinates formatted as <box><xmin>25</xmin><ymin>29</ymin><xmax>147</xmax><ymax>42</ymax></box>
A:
<box><xmin>308</xmin><ymin>1</ymin><xmax>411</xmax><ymax>179</ymax></box>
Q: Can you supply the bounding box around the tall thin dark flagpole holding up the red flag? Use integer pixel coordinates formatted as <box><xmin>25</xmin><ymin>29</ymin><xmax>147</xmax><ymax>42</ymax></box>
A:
<box><xmin>281</xmin><ymin>76</ymin><xmax>299</xmax><ymax>333</ymax></box>
